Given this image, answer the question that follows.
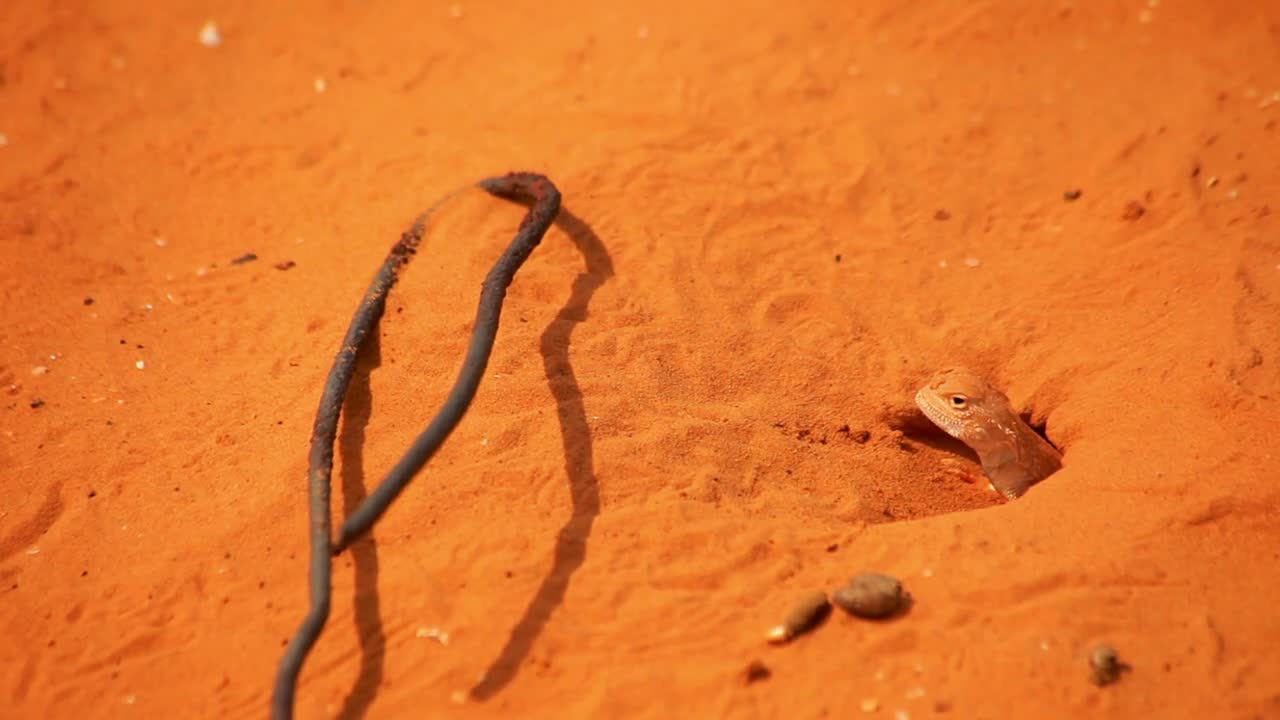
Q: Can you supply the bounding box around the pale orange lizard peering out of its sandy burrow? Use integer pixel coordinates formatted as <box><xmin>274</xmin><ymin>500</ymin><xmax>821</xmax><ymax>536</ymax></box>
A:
<box><xmin>915</xmin><ymin>368</ymin><xmax>1062</xmax><ymax>500</ymax></box>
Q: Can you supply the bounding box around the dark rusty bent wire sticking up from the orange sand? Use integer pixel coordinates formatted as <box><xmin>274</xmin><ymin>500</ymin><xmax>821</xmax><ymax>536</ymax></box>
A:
<box><xmin>271</xmin><ymin>173</ymin><xmax>561</xmax><ymax>720</ymax></box>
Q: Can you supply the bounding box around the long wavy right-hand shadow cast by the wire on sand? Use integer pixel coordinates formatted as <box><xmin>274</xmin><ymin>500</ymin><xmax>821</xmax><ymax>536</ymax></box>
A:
<box><xmin>471</xmin><ymin>208</ymin><xmax>613</xmax><ymax>701</ymax></box>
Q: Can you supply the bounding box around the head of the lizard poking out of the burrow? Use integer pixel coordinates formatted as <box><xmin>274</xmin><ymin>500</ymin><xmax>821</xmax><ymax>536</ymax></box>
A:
<box><xmin>915</xmin><ymin>368</ymin><xmax>1009</xmax><ymax>452</ymax></box>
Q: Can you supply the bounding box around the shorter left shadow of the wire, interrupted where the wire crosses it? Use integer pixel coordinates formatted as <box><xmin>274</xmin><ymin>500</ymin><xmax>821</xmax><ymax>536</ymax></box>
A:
<box><xmin>338</xmin><ymin>331</ymin><xmax>387</xmax><ymax>720</ymax></box>
